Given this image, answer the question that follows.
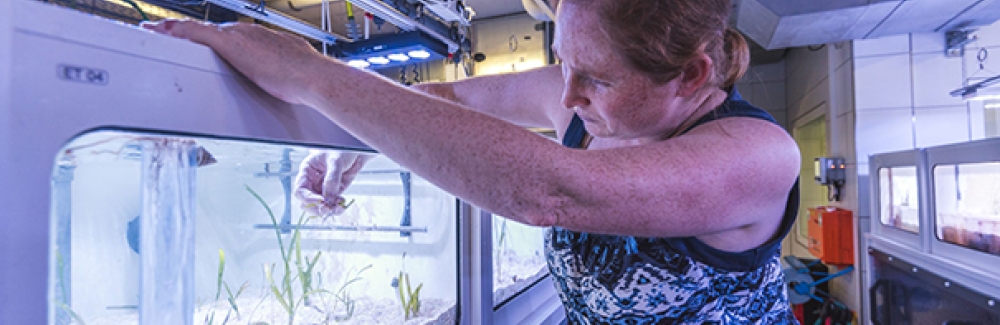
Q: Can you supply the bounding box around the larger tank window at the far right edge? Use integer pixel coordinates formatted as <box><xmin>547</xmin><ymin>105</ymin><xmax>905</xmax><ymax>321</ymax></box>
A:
<box><xmin>934</xmin><ymin>162</ymin><xmax>1000</xmax><ymax>255</ymax></box>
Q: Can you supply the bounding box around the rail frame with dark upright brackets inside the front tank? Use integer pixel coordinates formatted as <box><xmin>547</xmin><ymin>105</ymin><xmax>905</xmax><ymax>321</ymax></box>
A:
<box><xmin>254</xmin><ymin>153</ymin><xmax>418</xmax><ymax>237</ymax></box>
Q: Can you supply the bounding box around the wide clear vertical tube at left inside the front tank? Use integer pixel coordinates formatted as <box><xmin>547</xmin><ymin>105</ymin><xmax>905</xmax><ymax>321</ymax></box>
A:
<box><xmin>139</xmin><ymin>139</ymin><xmax>197</xmax><ymax>325</ymax></box>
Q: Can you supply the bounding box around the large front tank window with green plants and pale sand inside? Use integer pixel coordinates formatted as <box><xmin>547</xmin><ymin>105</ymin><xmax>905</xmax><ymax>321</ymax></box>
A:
<box><xmin>49</xmin><ymin>130</ymin><xmax>460</xmax><ymax>325</ymax></box>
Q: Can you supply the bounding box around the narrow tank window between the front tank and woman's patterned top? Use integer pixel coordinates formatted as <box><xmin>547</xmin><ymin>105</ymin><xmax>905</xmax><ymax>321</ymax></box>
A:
<box><xmin>492</xmin><ymin>215</ymin><xmax>549</xmax><ymax>307</ymax></box>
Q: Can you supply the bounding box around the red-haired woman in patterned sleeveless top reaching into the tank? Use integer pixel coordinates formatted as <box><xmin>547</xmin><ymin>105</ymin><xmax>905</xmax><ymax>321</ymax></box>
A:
<box><xmin>146</xmin><ymin>0</ymin><xmax>799</xmax><ymax>324</ymax></box>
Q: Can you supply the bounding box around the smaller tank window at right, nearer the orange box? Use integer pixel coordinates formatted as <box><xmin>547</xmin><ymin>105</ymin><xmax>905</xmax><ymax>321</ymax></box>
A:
<box><xmin>878</xmin><ymin>166</ymin><xmax>920</xmax><ymax>233</ymax></box>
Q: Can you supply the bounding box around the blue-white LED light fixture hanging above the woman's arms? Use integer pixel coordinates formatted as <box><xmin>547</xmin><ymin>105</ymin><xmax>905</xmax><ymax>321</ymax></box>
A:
<box><xmin>337</xmin><ymin>31</ymin><xmax>449</xmax><ymax>70</ymax></box>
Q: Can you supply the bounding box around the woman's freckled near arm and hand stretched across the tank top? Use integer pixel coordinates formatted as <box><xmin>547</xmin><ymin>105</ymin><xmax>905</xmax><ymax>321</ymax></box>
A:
<box><xmin>146</xmin><ymin>23</ymin><xmax>799</xmax><ymax>246</ymax></box>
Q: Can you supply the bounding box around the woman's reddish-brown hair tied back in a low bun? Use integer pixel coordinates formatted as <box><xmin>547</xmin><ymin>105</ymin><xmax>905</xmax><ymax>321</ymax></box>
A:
<box><xmin>562</xmin><ymin>0</ymin><xmax>750</xmax><ymax>88</ymax></box>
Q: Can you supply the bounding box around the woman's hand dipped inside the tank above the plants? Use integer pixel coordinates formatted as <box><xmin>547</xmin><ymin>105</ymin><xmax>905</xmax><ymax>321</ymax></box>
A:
<box><xmin>294</xmin><ymin>150</ymin><xmax>372</xmax><ymax>218</ymax></box>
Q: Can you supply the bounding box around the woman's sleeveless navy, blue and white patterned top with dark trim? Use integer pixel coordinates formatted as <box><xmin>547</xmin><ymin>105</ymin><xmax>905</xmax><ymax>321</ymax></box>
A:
<box><xmin>545</xmin><ymin>89</ymin><xmax>799</xmax><ymax>324</ymax></box>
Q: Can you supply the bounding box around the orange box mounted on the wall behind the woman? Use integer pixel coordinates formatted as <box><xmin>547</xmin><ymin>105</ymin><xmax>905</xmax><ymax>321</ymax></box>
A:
<box><xmin>809</xmin><ymin>206</ymin><xmax>854</xmax><ymax>265</ymax></box>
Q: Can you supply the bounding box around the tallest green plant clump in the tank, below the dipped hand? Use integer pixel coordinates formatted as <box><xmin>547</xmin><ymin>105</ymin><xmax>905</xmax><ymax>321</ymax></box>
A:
<box><xmin>245</xmin><ymin>186</ymin><xmax>329</xmax><ymax>324</ymax></box>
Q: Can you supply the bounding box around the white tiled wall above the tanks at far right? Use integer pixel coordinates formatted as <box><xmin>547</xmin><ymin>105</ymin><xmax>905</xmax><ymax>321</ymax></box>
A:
<box><xmin>854</xmin><ymin>19</ymin><xmax>1000</xmax><ymax>167</ymax></box>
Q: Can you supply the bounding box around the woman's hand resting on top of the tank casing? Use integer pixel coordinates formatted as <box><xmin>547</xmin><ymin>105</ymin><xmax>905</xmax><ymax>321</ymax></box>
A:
<box><xmin>142</xmin><ymin>19</ymin><xmax>331</xmax><ymax>104</ymax></box>
